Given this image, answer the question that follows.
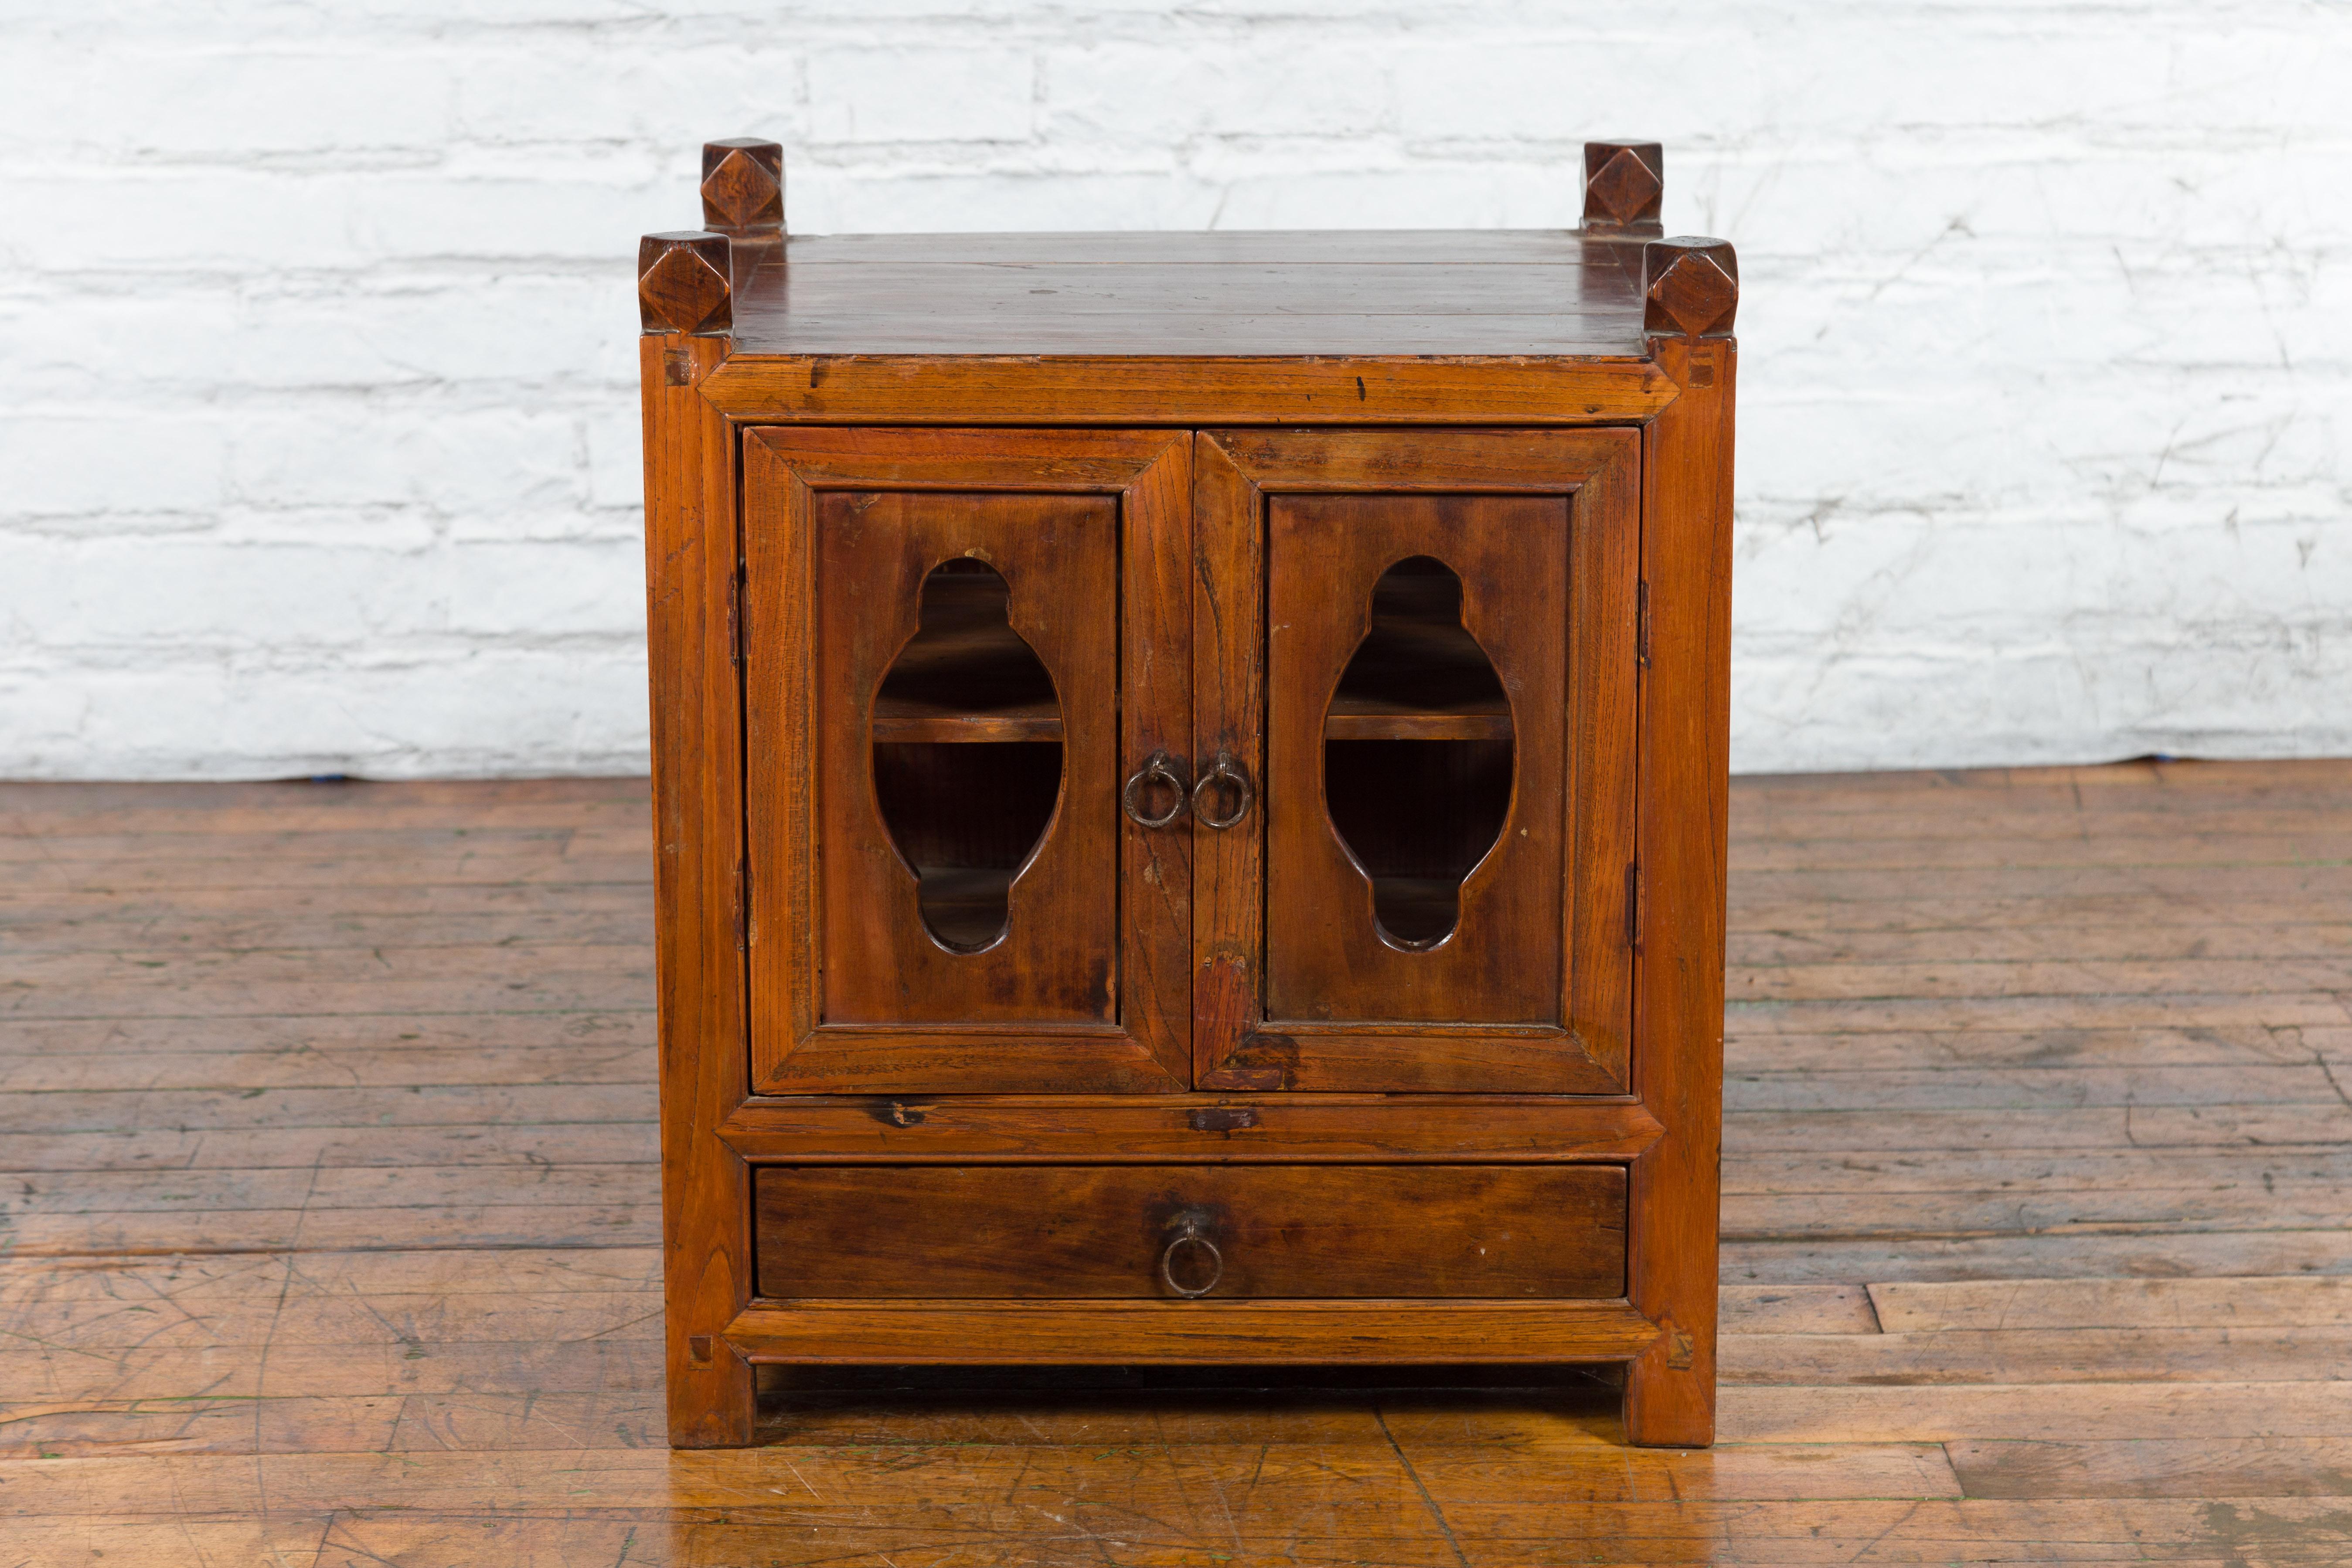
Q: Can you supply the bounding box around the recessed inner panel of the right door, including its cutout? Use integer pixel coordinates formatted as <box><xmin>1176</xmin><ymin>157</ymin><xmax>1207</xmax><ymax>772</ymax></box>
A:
<box><xmin>1266</xmin><ymin>496</ymin><xmax>1569</xmax><ymax>1025</ymax></box>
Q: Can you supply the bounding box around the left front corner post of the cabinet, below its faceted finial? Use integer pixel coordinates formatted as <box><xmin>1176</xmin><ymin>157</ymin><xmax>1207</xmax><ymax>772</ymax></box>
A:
<box><xmin>640</xmin><ymin>336</ymin><xmax>752</xmax><ymax>1448</ymax></box>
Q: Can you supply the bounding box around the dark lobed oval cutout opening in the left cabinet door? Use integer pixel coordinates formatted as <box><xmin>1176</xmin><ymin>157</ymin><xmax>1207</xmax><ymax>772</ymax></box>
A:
<box><xmin>873</xmin><ymin>559</ymin><xmax>1061</xmax><ymax>954</ymax></box>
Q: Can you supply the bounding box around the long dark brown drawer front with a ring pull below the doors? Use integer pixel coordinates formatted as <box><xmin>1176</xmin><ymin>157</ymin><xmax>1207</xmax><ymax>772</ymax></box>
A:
<box><xmin>755</xmin><ymin>1166</ymin><xmax>1625</xmax><ymax>1300</ymax></box>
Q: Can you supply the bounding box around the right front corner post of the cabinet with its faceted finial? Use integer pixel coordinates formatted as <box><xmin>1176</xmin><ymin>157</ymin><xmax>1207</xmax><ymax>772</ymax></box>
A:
<box><xmin>1625</xmin><ymin>240</ymin><xmax>1738</xmax><ymax>1448</ymax></box>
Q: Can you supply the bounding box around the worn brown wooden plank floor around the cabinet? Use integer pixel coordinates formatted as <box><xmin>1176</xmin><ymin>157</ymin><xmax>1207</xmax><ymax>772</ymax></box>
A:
<box><xmin>0</xmin><ymin>762</ymin><xmax>2352</xmax><ymax>1568</ymax></box>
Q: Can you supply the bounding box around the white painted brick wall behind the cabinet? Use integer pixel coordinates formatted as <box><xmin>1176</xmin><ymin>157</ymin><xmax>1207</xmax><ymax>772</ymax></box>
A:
<box><xmin>0</xmin><ymin>0</ymin><xmax>2352</xmax><ymax>778</ymax></box>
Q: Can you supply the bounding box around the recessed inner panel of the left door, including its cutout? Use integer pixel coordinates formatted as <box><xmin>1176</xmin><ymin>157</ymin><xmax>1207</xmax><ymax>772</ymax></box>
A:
<box><xmin>814</xmin><ymin>491</ymin><xmax>1120</xmax><ymax>1025</ymax></box>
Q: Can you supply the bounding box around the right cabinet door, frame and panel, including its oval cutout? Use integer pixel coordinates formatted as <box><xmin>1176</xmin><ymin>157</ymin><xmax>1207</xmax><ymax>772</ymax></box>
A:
<box><xmin>1195</xmin><ymin>430</ymin><xmax>1639</xmax><ymax>1093</ymax></box>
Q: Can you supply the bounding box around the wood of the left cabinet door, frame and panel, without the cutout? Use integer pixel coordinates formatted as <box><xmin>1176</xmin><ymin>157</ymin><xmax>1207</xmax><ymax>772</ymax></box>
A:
<box><xmin>743</xmin><ymin>430</ymin><xmax>1190</xmax><ymax>1093</ymax></box>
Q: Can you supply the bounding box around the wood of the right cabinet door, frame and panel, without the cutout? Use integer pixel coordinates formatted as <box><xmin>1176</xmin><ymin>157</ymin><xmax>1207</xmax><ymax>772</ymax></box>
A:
<box><xmin>1192</xmin><ymin>430</ymin><xmax>1639</xmax><ymax>1093</ymax></box>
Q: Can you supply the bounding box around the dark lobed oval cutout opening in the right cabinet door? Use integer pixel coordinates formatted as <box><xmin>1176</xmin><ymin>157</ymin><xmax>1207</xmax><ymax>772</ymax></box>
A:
<box><xmin>1324</xmin><ymin>555</ymin><xmax>1515</xmax><ymax>952</ymax></box>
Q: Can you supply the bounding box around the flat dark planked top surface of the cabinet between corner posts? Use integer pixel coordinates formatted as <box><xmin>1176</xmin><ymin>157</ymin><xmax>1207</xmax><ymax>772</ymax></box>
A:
<box><xmin>734</xmin><ymin>230</ymin><xmax>1644</xmax><ymax>360</ymax></box>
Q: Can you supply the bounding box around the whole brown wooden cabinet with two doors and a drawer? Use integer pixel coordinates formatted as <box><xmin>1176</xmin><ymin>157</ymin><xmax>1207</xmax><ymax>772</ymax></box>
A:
<box><xmin>640</xmin><ymin>141</ymin><xmax>1736</xmax><ymax>1446</ymax></box>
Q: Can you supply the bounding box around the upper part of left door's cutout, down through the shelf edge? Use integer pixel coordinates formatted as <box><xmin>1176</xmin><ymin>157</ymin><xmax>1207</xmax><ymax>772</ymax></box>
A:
<box><xmin>873</xmin><ymin>571</ymin><xmax>1061</xmax><ymax>743</ymax></box>
